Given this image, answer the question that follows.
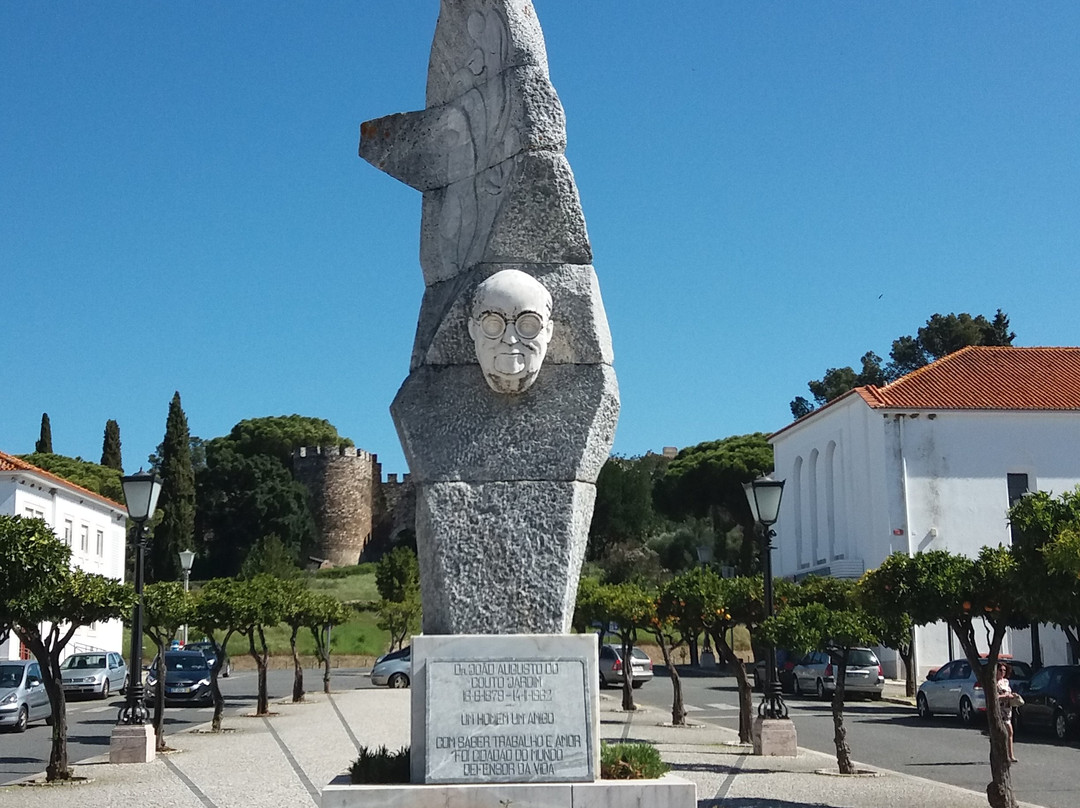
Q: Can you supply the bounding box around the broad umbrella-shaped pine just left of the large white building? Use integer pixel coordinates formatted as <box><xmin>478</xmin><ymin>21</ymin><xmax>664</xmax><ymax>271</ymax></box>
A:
<box><xmin>654</xmin><ymin>432</ymin><xmax>772</xmax><ymax>575</ymax></box>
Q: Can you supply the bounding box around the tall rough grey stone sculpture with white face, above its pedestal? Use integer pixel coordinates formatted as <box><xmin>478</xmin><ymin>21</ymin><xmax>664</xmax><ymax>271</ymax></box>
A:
<box><xmin>360</xmin><ymin>0</ymin><xmax>619</xmax><ymax>634</ymax></box>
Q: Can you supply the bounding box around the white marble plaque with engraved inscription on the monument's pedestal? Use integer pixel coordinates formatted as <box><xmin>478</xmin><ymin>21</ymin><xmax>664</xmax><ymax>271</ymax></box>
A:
<box><xmin>424</xmin><ymin>657</ymin><xmax>594</xmax><ymax>783</ymax></box>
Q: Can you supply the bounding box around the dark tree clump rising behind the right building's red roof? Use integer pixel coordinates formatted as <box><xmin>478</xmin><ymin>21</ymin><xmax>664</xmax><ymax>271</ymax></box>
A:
<box><xmin>791</xmin><ymin>309</ymin><xmax>1016</xmax><ymax>418</ymax></box>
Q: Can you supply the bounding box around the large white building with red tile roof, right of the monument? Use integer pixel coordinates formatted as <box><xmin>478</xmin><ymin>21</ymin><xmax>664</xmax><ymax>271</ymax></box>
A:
<box><xmin>770</xmin><ymin>348</ymin><xmax>1080</xmax><ymax>676</ymax></box>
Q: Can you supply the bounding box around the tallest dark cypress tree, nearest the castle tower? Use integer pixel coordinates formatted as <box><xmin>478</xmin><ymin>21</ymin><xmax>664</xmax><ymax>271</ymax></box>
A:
<box><xmin>147</xmin><ymin>392</ymin><xmax>195</xmax><ymax>581</ymax></box>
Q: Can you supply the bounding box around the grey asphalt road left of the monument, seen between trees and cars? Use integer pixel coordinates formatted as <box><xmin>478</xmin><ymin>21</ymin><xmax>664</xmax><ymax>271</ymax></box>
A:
<box><xmin>0</xmin><ymin>669</ymin><xmax>370</xmax><ymax>785</ymax></box>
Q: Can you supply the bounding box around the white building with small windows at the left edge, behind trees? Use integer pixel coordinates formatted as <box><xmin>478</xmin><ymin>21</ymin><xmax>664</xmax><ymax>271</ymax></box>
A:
<box><xmin>0</xmin><ymin>452</ymin><xmax>127</xmax><ymax>660</ymax></box>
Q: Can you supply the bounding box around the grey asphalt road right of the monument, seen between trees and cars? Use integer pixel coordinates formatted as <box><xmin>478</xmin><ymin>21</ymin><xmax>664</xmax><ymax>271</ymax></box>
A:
<box><xmin>630</xmin><ymin>668</ymin><xmax>1080</xmax><ymax>808</ymax></box>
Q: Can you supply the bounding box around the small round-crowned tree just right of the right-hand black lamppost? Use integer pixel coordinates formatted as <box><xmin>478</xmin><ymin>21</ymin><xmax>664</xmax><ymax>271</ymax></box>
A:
<box><xmin>761</xmin><ymin>578</ymin><xmax>882</xmax><ymax>775</ymax></box>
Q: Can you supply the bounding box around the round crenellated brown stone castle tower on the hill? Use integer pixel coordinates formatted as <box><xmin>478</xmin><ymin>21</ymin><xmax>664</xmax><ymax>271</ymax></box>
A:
<box><xmin>293</xmin><ymin>446</ymin><xmax>381</xmax><ymax>566</ymax></box>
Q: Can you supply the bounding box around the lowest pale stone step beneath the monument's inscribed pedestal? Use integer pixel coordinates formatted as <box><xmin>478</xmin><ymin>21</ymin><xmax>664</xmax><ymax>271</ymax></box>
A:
<box><xmin>321</xmin><ymin>775</ymin><xmax>698</xmax><ymax>808</ymax></box>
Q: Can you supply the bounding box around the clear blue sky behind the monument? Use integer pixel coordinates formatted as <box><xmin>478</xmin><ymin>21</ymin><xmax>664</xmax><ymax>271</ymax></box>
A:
<box><xmin>0</xmin><ymin>0</ymin><xmax>1080</xmax><ymax>472</ymax></box>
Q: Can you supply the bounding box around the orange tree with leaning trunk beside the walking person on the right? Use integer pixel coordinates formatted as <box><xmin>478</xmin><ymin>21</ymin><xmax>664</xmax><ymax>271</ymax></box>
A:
<box><xmin>862</xmin><ymin>547</ymin><xmax>1030</xmax><ymax>808</ymax></box>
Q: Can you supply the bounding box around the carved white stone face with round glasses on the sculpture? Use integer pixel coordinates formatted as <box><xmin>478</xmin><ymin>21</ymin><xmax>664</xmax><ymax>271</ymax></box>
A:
<box><xmin>469</xmin><ymin>269</ymin><xmax>553</xmax><ymax>393</ymax></box>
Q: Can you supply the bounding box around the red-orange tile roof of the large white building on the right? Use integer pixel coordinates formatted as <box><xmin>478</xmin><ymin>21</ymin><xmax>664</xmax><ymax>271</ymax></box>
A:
<box><xmin>854</xmin><ymin>347</ymin><xmax>1080</xmax><ymax>410</ymax></box>
